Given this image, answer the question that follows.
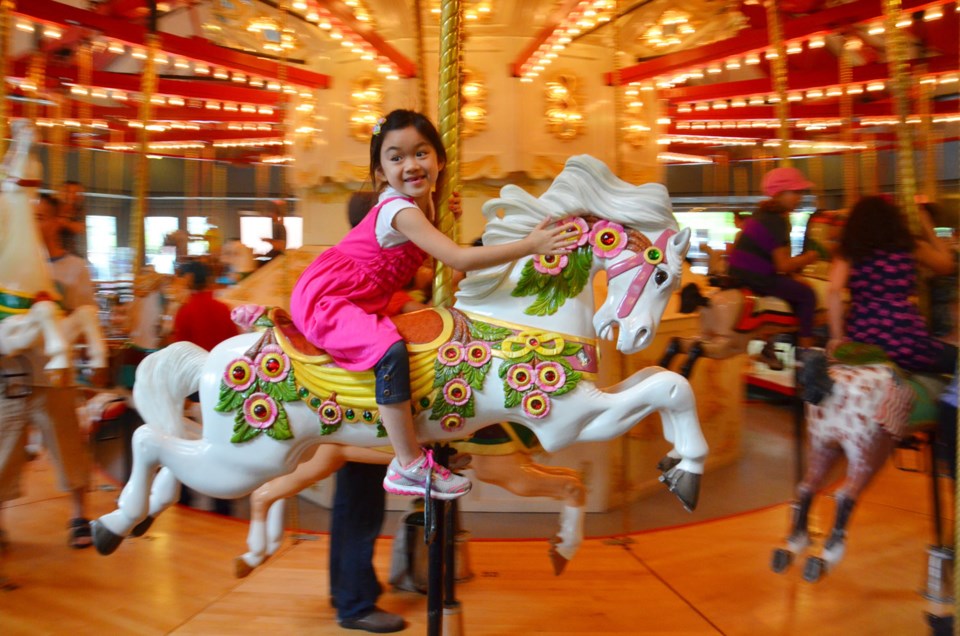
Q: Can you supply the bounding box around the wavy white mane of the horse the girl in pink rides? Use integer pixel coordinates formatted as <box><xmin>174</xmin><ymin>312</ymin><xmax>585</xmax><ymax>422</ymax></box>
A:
<box><xmin>457</xmin><ymin>155</ymin><xmax>679</xmax><ymax>300</ymax></box>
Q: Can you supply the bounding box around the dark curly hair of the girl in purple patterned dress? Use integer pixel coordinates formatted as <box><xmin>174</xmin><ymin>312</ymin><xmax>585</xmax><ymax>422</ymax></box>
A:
<box><xmin>839</xmin><ymin>196</ymin><xmax>916</xmax><ymax>263</ymax></box>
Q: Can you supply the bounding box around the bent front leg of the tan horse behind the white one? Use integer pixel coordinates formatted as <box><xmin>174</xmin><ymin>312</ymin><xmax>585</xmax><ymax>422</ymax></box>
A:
<box><xmin>470</xmin><ymin>453</ymin><xmax>587</xmax><ymax>575</ymax></box>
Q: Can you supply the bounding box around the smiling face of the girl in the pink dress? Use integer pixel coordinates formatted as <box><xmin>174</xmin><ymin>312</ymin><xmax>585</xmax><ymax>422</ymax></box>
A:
<box><xmin>377</xmin><ymin>126</ymin><xmax>443</xmax><ymax>209</ymax></box>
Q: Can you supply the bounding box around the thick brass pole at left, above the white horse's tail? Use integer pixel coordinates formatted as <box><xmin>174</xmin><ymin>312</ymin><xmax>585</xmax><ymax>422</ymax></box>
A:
<box><xmin>130</xmin><ymin>27</ymin><xmax>160</xmax><ymax>272</ymax></box>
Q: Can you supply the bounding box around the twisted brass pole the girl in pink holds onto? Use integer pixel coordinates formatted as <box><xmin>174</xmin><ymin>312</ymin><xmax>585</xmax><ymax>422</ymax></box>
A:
<box><xmin>434</xmin><ymin>0</ymin><xmax>463</xmax><ymax>307</ymax></box>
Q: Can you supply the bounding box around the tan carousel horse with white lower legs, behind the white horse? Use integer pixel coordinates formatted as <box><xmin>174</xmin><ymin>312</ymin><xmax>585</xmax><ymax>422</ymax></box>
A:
<box><xmin>234</xmin><ymin>423</ymin><xmax>587</xmax><ymax>578</ymax></box>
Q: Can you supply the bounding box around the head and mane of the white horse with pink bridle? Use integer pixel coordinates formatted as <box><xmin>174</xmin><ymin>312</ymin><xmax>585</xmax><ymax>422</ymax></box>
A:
<box><xmin>457</xmin><ymin>155</ymin><xmax>690</xmax><ymax>354</ymax></box>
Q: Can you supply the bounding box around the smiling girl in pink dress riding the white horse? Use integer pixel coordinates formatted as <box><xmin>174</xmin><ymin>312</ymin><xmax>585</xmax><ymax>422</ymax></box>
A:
<box><xmin>290</xmin><ymin>110</ymin><xmax>577</xmax><ymax>499</ymax></box>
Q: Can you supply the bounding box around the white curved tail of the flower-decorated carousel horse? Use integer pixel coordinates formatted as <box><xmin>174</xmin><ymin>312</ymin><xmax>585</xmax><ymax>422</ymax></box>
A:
<box><xmin>133</xmin><ymin>342</ymin><xmax>210</xmax><ymax>437</ymax></box>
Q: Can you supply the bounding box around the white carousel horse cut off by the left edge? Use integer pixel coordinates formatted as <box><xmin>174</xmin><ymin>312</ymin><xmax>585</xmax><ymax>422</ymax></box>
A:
<box><xmin>0</xmin><ymin>121</ymin><xmax>107</xmax><ymax>375</ymax></box>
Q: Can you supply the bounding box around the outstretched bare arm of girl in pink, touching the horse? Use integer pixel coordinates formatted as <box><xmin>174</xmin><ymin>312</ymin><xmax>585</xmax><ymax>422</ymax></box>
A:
<box><xmin>393</xmin><ymin>208</ymin><xmax>577</xmax><ymax>272</ymax></box>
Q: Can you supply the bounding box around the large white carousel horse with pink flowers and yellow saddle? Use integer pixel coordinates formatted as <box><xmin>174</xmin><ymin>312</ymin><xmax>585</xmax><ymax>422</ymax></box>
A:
<box><xmin>91</xmin><ymin>156</ymin><xmax>707</xmax><ymax>554</ymax></box>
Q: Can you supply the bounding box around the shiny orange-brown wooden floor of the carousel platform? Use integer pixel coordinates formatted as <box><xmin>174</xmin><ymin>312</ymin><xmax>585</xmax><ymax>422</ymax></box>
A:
<box><xmin>0</xmin><ymin>452</ymin><xmax>952</xmax><ymax>636</ymax></box>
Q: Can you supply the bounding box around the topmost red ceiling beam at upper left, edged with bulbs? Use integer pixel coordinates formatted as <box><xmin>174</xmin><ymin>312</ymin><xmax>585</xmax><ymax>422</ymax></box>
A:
<box><xmin>13</xmin><ymin>0</ymin><xmax>330</xmax><ymax>90</ymax></box>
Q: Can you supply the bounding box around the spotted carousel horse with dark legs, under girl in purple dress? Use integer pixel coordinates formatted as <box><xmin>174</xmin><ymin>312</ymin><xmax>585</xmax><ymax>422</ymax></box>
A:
<box><xmin>771</xmin><ymin>344</ymin><xmax>944</xmax><ymax>583</ymax></box>
